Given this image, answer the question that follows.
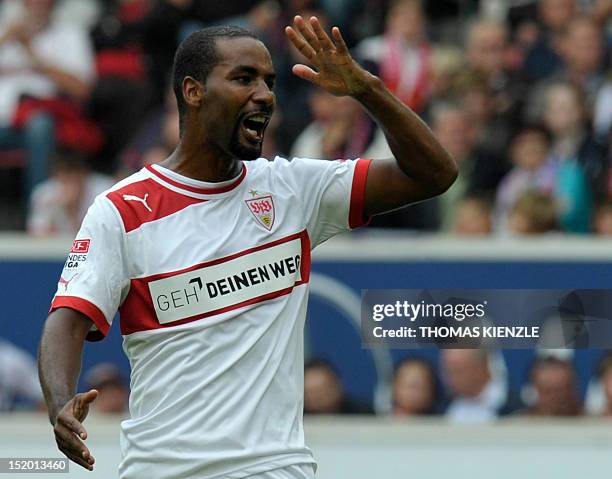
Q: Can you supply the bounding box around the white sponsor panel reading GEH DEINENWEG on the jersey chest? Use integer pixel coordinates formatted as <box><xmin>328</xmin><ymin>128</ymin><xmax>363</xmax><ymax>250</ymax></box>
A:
<box><xmin>149</xmin><ymin>238</ymin><xmax>302</xmax><ymax>324</ymax></box>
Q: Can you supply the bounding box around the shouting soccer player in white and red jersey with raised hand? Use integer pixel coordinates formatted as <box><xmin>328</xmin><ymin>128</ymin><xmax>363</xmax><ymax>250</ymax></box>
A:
<box><xmin>39</xmin><ymin>16</ymin><xmax>457</xmax><ymax>479</ymax></box>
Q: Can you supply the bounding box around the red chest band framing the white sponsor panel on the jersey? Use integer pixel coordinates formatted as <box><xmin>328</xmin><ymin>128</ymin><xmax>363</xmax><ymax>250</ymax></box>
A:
<box><xmin>119</xmin><ymin>230</ymin><xmax>311</xmax><ymax>336</ymax></box>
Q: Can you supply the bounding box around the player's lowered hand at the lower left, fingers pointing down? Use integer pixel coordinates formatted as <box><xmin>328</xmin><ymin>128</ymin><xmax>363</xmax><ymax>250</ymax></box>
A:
<box><xmin>53</xmin><ymin>389</ymin><xmax>98</xmax><ymax>471</ymax></box>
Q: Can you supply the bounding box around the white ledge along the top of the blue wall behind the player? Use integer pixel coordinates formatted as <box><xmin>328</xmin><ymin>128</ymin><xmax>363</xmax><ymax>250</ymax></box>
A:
<box><xmin>0</xmin><ymin>230</ymin><xmax>612</xmax><ymax>262</ymax></box>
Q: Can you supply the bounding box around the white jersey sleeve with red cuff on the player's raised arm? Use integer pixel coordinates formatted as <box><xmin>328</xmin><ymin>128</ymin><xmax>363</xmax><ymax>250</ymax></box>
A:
<box><xmin>280</xmin><ymin>158</ymin><xmax>371</xmax><ymax>248</ymax></box>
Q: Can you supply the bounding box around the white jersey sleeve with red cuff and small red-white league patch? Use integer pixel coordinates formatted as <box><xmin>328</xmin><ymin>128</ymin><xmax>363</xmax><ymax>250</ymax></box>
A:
<box><xmin>50</xmin><ymin>197</ymin><xmax>130</xmax><ymax>341</ymax></box>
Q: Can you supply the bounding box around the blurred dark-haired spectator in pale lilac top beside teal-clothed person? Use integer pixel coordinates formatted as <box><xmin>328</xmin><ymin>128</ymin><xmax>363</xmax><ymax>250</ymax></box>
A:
<box><xmin>495</xmin><ymin>125</ymin><xmax>557</xmax><ymax>232</ymax></box>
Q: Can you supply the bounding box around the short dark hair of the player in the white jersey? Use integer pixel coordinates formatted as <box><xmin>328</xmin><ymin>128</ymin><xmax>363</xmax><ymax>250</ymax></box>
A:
<box><xmin>172</xmin><ymin>26</ymin><xmax>259</xmax><ymax>132</ymax></box>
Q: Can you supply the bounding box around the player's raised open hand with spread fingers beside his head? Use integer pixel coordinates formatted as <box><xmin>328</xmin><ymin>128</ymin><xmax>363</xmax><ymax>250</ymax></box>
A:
<box><xmin>285</xmin><ymin>15</ymin><xmax>373</xmax><ymax>97</ymax></box>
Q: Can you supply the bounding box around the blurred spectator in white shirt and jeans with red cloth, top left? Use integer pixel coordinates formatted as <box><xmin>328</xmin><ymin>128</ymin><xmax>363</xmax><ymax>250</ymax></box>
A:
<box><xmin>0</xmin><ymin>0</ymin><xmax>96</xmax><ymax>197</ymax></box>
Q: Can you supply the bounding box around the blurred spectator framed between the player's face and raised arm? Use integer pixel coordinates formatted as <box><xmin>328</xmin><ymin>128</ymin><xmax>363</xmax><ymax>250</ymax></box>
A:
<box><xmin>291</xmin><ymin>90</ymin><xmax>393</xmax><ymax>160</ymax></box>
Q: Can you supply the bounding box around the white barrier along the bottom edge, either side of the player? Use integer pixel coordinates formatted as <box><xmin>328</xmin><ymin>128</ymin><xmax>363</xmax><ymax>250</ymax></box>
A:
<box><xmin>0</xmin><ymin>414</ymin><xmax>612</xmax><ymax>479</ymax></box>
